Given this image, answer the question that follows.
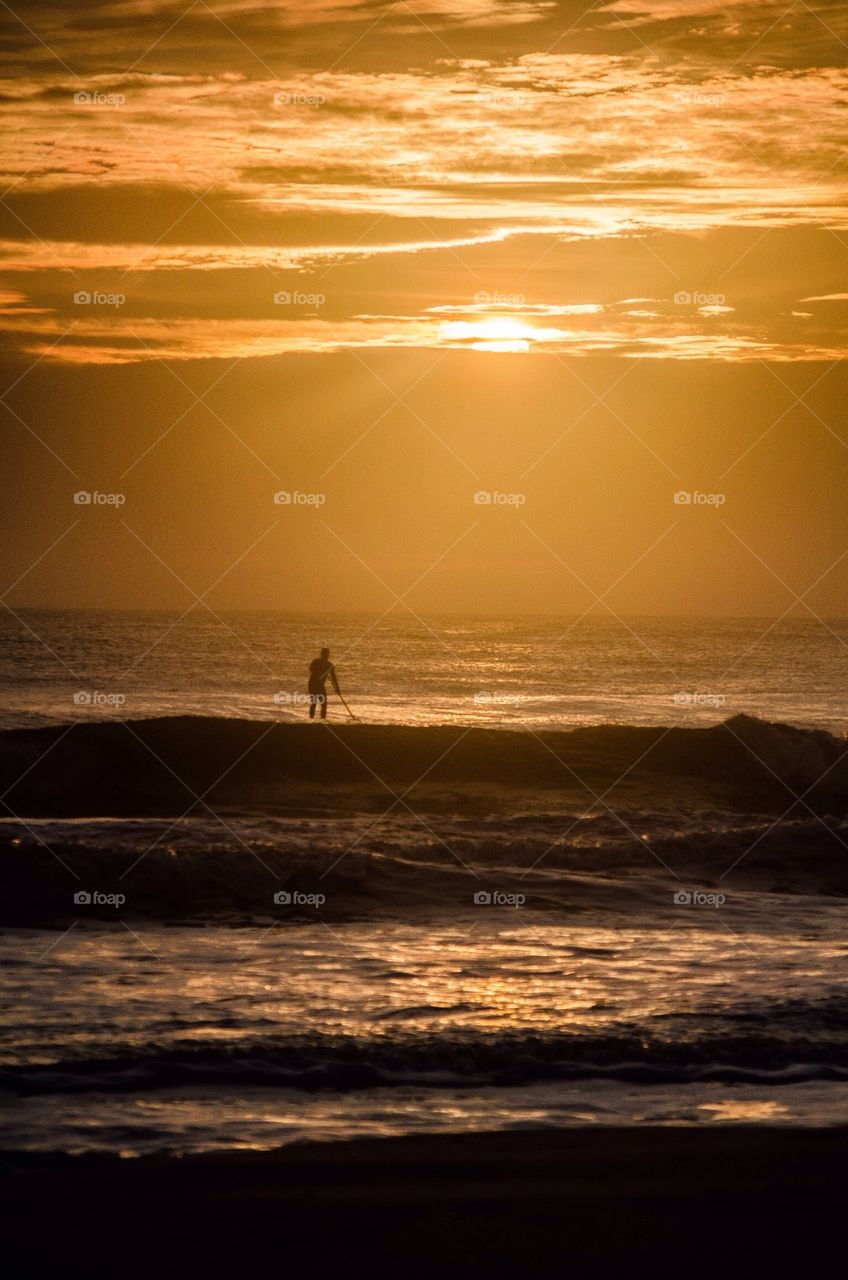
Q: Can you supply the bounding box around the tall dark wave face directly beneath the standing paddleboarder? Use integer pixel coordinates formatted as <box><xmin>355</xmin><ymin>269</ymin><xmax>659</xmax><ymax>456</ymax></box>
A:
<box><xmin>0</xmin><ymin>716</ymin><xmax>848</xmax><ymax>815</ymax></box>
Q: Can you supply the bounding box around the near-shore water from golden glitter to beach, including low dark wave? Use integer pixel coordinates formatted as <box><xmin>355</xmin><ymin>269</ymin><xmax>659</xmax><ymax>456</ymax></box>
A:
<box><xmin>6</xmin><ymin>895</ymin><xmax>848</xmax><ymax>1153</ymax></box>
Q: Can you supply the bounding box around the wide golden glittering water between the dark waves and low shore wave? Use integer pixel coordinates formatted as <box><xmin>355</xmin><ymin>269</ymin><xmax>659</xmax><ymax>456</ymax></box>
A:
<box><xmin>0</xmin><ymin>916</ymin><xmax>847</xmax><ymax>1066</ymax></box>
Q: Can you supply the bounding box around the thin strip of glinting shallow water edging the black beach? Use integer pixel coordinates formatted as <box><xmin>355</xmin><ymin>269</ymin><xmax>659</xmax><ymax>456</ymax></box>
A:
<box><xmin>6</xmin><ymin>1080</ymin><xmax>848</xmax><ymax>1156</ymax></box>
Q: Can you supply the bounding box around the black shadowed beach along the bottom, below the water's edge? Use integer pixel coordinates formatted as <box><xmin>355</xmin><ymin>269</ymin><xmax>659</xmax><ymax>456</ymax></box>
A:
<box><xmin>0</xmin><ymin>1126</ymin><xmax>848</xmax><ymax>1280</ymax></box>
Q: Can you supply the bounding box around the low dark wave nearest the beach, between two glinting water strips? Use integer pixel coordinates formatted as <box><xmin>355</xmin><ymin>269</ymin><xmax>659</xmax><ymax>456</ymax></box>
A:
<box><xmin>6</xmin><ymin>1006</ymin><xmax>848</xmax><ymax>1096</ymax></box>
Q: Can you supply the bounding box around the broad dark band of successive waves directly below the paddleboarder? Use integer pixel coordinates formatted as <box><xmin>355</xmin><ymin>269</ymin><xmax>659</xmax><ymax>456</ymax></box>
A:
<box><xmin>0</xmin><ymin>717</ymin><xmax>848</xmax><ymax>927</ymax></box>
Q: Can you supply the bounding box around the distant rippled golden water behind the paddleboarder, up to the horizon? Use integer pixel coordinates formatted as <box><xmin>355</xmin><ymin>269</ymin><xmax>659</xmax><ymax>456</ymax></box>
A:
<box><xmin>0</xmin><ymin>611</ymin><xmax>848</xmax><ymax>731</ymax></box>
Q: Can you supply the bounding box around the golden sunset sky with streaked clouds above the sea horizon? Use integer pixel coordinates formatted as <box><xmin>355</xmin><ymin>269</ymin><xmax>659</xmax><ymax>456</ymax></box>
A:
<box><xmin>0</xmin><ymin>0</ymin><xmax>848</xmax><ymax>617</ymax></box>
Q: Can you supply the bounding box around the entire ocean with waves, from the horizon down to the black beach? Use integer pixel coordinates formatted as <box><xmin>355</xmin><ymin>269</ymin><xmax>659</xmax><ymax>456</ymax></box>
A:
<box><xmin>0</xmin><ymin>611</ymin><xmax>848</xmax><ymax>1156</ymax></box>
